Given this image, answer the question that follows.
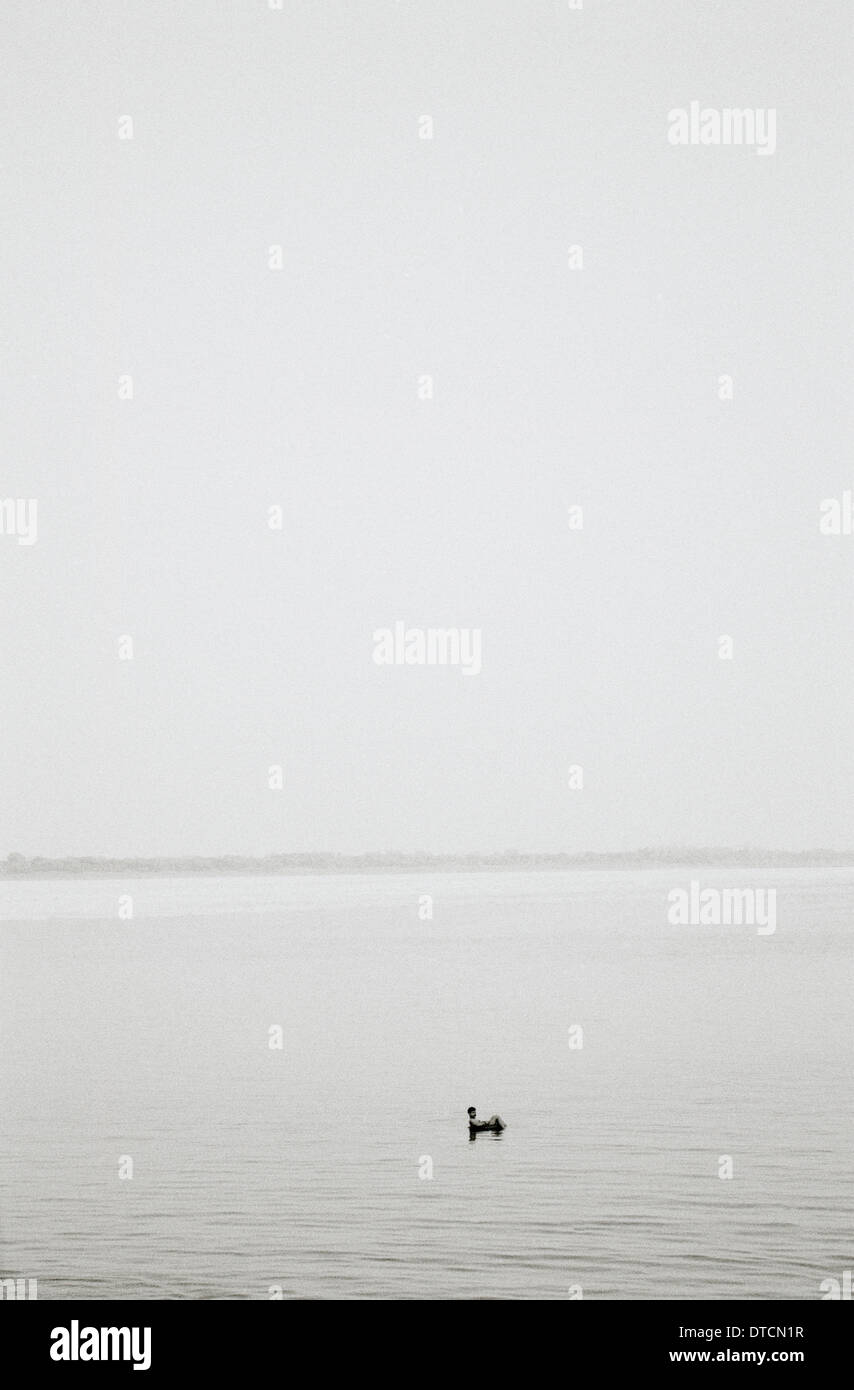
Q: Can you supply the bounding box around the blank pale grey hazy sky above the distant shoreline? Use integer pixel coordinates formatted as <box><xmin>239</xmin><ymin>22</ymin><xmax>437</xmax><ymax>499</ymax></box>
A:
<box><xmin>0</xmin><ymin>0</ymin><xmax>854</xmax><ymax>855</ymax></box>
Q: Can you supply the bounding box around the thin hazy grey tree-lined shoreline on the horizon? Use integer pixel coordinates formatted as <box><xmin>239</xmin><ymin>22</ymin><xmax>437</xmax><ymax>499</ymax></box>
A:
<box><xmin>0</xmin><ymin>849</ymin><xmax>854</xmax><ymax>880</ymax></box>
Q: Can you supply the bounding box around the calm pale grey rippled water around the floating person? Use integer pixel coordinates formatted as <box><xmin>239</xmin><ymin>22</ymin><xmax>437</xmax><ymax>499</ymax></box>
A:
<box><xmin>0</xmin><ymin>869</ymin><xmax>854</xmax><ymax>1300</ymax></box>
